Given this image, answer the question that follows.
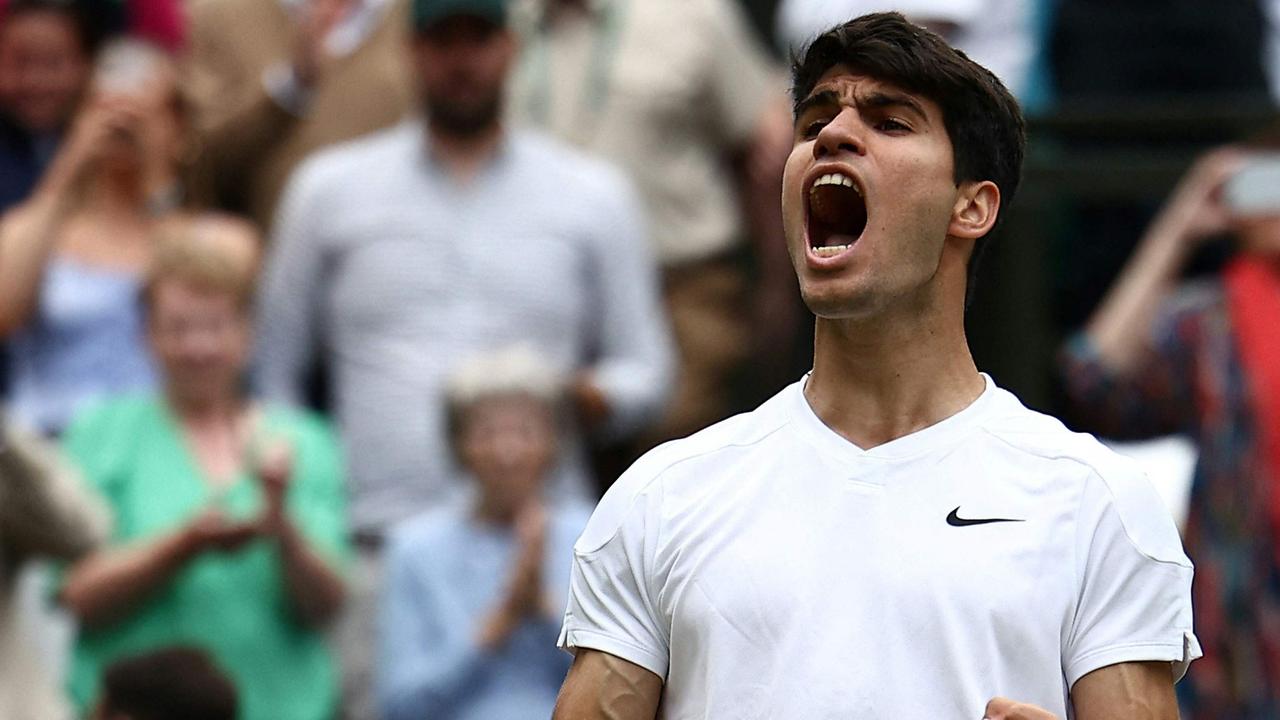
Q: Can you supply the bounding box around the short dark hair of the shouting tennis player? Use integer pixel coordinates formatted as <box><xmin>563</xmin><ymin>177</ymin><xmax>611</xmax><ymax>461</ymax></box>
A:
<box><xmin>791</xmin><ymin>13</ymin><xmax>1027</xmax><ymax>297</ymax></box>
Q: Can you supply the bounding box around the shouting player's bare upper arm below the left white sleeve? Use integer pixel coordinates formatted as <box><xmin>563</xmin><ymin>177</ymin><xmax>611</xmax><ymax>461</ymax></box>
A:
<box><xmin>552</xmin><ymin>648</ymin><xmax>662</xmax><ymax>720</ymax></box>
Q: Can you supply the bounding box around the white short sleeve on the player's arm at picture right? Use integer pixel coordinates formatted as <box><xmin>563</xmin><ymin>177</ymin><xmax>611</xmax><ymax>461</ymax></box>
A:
<box><xmin>1062</xmin><ymin>464</ymin><xmax>1201</xmax><ymax>685</ymax></box>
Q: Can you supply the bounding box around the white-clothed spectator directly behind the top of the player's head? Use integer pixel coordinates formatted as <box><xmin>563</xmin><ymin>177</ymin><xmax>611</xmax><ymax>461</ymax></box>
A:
<box><xmin>778</xmin><ymin>0</ymin><xmax>1039</xmax><ymax>97</ymax></box>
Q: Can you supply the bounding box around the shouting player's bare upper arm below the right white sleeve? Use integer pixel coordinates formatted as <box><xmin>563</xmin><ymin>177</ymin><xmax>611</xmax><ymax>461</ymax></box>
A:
<box><xmin>1071</xmin><ymin>662</ymin><xmax>1178</xmax><ymax>720</ymax></box>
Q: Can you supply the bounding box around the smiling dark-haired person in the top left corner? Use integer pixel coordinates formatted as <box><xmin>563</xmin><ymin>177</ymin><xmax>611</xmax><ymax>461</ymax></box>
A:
<box><xmin>0</xmin><ymin>0</ymin><xmax>97</xmax><ymax>214</ymax></box>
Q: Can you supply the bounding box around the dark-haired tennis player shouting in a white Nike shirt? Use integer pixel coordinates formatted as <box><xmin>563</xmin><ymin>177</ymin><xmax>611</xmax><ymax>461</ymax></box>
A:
<box><xmin>556</xmin><ymin>14</ymin><xmax>1199</xmax><ymax>720</ymax></box>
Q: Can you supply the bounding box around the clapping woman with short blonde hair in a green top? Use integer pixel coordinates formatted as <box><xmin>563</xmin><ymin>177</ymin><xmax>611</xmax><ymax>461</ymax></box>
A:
<box><xmin>60</xmin><ymin>217</ymin><xmax>346</xmax><ymax>720</ymax></box>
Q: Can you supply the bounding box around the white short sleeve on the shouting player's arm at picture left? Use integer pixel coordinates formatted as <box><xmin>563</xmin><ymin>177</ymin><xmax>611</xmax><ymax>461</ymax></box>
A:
<box><xmin>559</xmin><ymin>469</ymin><xmax>669</xmax><ymax>679</ymax></box>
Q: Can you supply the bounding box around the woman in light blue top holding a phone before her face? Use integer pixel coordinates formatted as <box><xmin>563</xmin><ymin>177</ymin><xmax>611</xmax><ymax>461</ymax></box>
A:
<box><xmin>0</xmin><ymin>42</ymin><xmax>186</xmax><ymax>434</ymax></box>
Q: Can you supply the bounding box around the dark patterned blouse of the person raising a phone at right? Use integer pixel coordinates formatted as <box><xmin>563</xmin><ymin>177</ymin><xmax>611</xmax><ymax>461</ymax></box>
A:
<box><xmin>1062</xmin><ymin>279</ymin><xmax>1280</xmax><ymax>720</ymax></box>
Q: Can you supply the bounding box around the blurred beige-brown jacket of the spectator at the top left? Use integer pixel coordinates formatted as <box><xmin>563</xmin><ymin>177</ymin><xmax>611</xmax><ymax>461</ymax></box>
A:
<box><xmin>186</xmin><ymin>0</ymin><xmax>413</xmax><ymax>229</ymax></box>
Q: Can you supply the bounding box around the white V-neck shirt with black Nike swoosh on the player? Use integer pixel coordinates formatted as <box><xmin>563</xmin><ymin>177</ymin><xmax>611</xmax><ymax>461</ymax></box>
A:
<box><xmin>559</xmin><ymin>378</ymin><xmax>1199</xmax><ymax>720</ymax></box>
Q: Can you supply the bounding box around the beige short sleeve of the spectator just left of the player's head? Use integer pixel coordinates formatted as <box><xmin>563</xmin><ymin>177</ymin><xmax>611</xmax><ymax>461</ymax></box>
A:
<box><xmin>699</xmin><ymin>0</ymin><xmax>785</xmax><ymax>146</ymax></box>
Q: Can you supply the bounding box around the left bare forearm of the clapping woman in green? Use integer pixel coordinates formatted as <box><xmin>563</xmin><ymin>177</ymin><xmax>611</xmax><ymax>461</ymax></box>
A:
<box><xmin>61</xmin><ymin>532</ymin><xmax>195</xmax><ymax>626</ymax></box>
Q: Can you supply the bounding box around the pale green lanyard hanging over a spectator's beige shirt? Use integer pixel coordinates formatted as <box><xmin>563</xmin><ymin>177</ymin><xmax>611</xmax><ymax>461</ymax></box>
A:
<box><xmin>529</xmin><ymin>0</ymin><xmax>625</xmax><ymax>142</ymax></box>
